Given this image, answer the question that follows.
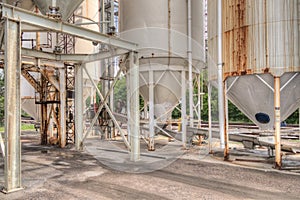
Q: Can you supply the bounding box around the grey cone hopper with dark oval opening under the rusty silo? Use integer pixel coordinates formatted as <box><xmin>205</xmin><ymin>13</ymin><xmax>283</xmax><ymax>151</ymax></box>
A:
<box><xmin>227</xmin><ymin>72</ymin><xmax>300</xmax><ymax>130</ymax></box>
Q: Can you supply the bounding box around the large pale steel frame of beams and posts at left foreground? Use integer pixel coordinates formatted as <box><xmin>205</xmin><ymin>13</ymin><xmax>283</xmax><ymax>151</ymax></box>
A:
<box><xmin>0</xmin><ymin>3</ymin><xmax>140</xmax><ymax>193</ymax></box>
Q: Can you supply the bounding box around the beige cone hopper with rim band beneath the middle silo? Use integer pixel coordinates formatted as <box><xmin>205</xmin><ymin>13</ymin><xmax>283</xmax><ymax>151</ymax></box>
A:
<box><xmin>139</xmin><ymin>58</ymin><xmax>186</xmax><ymax>122</ymax></box>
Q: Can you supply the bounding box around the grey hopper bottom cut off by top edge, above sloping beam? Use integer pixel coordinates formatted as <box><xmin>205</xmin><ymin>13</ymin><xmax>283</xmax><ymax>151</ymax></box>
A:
<box><xmin>34</xmin><ymin>0</ymin><xmax>83</xmax><ymax>21</ymax></box>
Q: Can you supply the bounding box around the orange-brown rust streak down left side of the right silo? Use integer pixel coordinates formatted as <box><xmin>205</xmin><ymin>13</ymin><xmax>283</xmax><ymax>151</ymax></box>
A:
<box><xmin>223</xmin><ymin>0</ymin><xmax>248</xmax><ymax>76</ymax></box>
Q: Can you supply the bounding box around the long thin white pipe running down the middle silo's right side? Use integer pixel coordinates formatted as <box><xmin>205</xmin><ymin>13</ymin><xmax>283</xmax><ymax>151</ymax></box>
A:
<box><xmin>187</xmin><ymin>0</ymin><xmax>194</xmax><ymax>127</ymax></box>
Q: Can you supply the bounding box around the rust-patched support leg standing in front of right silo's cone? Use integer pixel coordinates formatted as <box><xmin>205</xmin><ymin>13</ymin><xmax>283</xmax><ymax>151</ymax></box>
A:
<box><xmin>274</xmin><ymin>77</ymin><xmax>281</xmax><ymax>169</ymax></box>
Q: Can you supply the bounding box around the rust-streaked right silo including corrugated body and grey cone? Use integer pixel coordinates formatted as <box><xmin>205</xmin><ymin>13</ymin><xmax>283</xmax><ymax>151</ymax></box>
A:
<box><xmin>208</xmin><ymin>0</ymin><xmax>300</xmax><ymax>130</ymax></box>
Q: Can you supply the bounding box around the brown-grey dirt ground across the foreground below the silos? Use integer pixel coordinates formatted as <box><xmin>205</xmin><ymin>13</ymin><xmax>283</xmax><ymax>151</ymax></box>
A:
<box><xmin>0</xmin><ymin>134</ymin><xmax>300</xmax><ymax>200</ymax></box>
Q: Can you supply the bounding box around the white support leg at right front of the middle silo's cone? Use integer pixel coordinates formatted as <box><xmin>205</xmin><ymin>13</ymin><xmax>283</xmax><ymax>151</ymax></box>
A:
<box><xmin>181</xmin><ymin>70</ymin><xmax>186</xmax><ymax>148</ymax></box>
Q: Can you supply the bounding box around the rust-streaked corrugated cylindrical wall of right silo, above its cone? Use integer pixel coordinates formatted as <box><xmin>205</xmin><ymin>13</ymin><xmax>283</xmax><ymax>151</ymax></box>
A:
<box><xmin>208</xmin><ymin>0</ymin><xmax>300</xmax><ymax>79</ymax></box>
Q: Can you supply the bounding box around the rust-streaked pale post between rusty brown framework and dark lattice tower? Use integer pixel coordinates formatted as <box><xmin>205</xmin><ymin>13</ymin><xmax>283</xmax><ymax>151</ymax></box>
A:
<box><xmin>59</xmin><ymin>68</ymin><xmax>67</xmax><ymax>148</ymax></box>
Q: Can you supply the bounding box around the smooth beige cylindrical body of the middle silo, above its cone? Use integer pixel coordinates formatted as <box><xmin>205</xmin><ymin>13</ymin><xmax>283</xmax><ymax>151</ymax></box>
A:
<box><xmin>120</xmin><ymin>0</ymin><xmax>204</xmax><ymax>61</ymax></box>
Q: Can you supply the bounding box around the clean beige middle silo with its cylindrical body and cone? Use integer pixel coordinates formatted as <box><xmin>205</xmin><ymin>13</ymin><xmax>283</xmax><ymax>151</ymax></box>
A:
<box><xmin>120</xmin><ymin>0</ymin><xmax>204</xmax><ymax>121</ymax></box>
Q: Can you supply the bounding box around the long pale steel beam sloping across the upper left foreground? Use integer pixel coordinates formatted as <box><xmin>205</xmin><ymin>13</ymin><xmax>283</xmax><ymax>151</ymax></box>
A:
<box><xmin>0</xmin><ymin>3</ymin><xmax>138</xmax><ymax>51</ymax></box>
